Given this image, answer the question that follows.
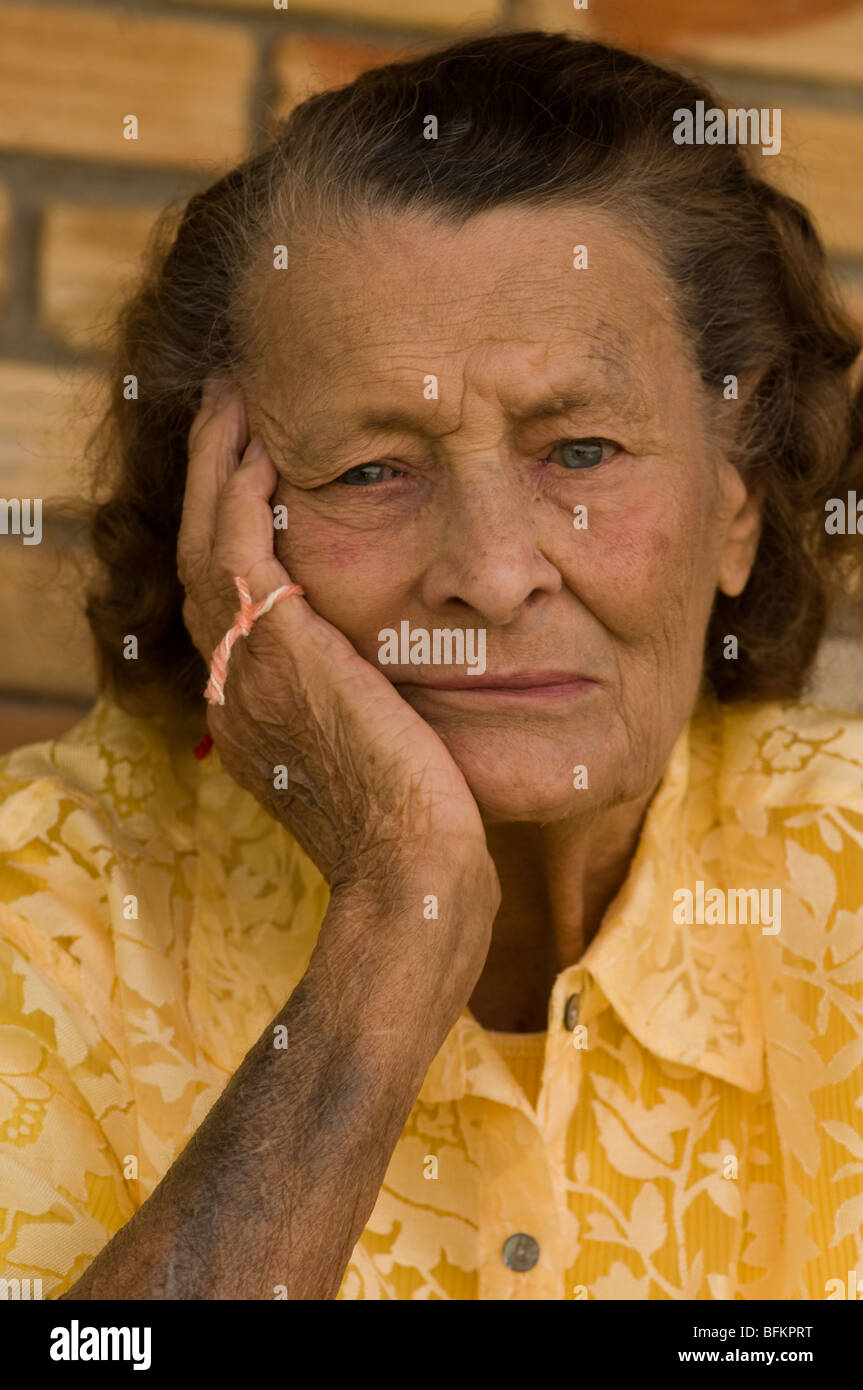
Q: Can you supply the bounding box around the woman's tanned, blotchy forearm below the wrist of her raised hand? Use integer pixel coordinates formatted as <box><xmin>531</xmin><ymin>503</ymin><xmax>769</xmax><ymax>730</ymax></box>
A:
<box><xmin>63</xmin><ymin>874</ymin><xmax>491</xmax><ymax>1300</ymax></box>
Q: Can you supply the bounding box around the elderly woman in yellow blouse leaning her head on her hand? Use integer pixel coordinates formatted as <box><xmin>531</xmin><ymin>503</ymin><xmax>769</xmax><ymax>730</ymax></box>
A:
<box><xmin>0</xmin><ymin>33</ymin><xmax>863</xmax><ymax>1300</ymax></box>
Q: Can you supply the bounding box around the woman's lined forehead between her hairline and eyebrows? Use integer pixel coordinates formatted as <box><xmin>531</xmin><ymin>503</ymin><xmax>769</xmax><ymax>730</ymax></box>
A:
<box><xmin>248</xmin><ymin>206</ymin><xmax>684</xmax><ymax>403</ymax></box>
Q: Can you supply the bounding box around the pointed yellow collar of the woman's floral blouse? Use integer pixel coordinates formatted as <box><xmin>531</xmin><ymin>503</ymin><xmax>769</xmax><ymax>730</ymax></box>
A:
<box><xmin>420</xmin><ymin>701</ymin><xmax>764</xmax><ymax>1104</ymax></box>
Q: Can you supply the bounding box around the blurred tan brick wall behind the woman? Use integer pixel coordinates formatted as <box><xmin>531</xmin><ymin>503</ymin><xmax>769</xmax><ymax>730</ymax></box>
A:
<box><xmin>0</xmin><ymin>0</ymin><xmax>863</xmax><ymax>752</ymax></box>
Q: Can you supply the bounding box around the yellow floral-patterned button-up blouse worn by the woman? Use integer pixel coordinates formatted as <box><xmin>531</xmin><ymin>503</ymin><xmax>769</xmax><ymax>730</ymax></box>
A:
<box><xmin>0</xmin><ymin>699</ymin><xmax>863</xmax><ymax>1300</ymax></box>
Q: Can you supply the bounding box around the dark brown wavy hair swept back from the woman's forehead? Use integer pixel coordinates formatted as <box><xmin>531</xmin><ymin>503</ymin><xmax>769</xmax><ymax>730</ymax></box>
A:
<box><xmin>80</xmin><ymin>32</ymin><xmax>863</xmax><ymax>714</ymax></box>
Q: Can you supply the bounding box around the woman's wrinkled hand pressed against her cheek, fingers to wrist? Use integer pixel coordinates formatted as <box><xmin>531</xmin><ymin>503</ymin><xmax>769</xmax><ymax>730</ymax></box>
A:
<box><xmin>178</xmin><ymin>392</ymin><xmax>499</xmax><ymax>929</ymax></box>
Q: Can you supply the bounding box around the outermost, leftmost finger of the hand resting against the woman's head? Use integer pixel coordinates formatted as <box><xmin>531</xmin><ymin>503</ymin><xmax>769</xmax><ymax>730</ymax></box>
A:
<box><xmin>176</xmin><ymin>384</ymin><xmax>247</xmax><ymax>588</ymax></box>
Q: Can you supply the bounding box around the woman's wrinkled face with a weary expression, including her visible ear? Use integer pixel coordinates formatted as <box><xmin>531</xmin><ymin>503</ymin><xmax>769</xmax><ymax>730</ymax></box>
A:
<box><xmin>246</xmin><ymin>204</ymin><xmax>759</xmax><ymax>821</ymax></box>
